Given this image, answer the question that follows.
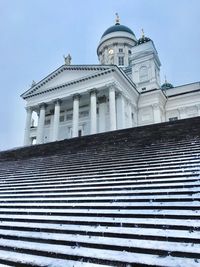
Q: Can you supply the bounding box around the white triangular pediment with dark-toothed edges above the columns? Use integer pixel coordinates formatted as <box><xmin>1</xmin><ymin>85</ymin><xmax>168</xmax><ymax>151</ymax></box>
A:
<box><xmin>21</xmin><ymin>65</ymin><xmax>110</xmax><ymax>98</ymax></box>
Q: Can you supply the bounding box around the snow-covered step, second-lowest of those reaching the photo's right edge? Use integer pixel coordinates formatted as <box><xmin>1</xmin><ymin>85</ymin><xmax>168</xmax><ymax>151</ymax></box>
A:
<box><xmin>0</xmin><ymin>229</ymin><xmax>200</xmax><ymax>258</ymax></box>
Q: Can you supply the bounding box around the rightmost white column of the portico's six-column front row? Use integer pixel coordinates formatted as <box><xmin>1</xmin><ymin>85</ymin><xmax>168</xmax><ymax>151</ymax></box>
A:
<box><xmin>109</xmin><ymin>86</ymin><xmax>116</xmax><ymax>131</ymax></box>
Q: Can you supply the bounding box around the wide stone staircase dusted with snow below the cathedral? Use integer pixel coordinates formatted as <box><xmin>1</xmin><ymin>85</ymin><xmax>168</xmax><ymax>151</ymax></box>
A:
<box><xmin>0</xmin><ymin>117</ymin><xmax>200</xmax><ymax>267</ymax></box>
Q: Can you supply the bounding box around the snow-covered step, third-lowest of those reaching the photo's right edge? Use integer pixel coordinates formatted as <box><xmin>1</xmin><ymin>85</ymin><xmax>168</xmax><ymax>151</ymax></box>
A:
<box><xmin>0</xmin><ymin>222</ymin><xmax>200</xmax><ymax>243</ymax></box>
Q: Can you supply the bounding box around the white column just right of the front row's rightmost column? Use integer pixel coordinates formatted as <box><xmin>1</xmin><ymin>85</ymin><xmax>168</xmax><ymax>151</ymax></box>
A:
<box><xmin>117</xmin><ymin>92</ymin><xmax>126</xmax><ymax>129</ymax></box>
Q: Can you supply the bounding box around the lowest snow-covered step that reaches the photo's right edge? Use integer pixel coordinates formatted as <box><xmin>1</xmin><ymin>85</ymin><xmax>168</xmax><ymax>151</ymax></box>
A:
<box><xmin>0</xmin><ymin>239</ymin><xmax>199</xmax><ymax>267</ymax></box>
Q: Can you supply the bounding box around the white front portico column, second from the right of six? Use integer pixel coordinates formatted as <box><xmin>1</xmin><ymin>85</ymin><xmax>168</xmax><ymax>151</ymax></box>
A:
<box><xmin>90</xmin><ymin>89</ymin><xmax>97</xmax><ymax>134</ymax></box>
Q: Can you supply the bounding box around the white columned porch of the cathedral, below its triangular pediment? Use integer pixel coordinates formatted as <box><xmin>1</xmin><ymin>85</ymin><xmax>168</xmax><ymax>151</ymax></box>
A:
<box><xmin>24</xmin><ymin>84</ymin><xmax>134</xmax><ymax>145</ymax></box>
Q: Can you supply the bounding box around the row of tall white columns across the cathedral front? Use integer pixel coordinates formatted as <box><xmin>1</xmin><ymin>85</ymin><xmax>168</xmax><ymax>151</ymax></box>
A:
<box><xmin>24</xmin><ymin>86</ymin><xmax>131</xmax><ymax>145</ymax></box>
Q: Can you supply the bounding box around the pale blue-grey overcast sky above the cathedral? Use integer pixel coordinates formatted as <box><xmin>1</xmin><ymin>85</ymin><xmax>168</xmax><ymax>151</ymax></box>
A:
<box><xmin>0</xmin><ymin>0</ymin><xmax>200</xmax><ymax>150</ymax></box>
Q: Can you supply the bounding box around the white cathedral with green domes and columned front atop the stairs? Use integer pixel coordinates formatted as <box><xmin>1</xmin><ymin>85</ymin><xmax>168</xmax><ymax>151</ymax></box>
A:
<box><xmin>22</xmin><ymin>16</ymin><xmax>200</xmax><ymax>146</ymax></box>
